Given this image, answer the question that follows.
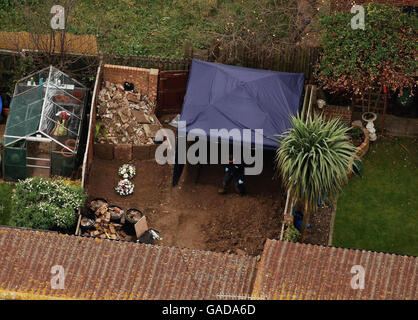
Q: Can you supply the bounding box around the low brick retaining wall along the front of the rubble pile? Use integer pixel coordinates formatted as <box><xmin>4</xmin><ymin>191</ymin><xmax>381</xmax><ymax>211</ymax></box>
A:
<box><xmin>93</xmin><ymin>142</ymin><xmax>158</xmax><ymax>161</ymax></box>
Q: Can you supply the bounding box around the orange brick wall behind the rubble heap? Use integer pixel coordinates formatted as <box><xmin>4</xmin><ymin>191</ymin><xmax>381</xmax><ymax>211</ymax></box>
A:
<box><xmin>103</xmin><ymin>64</ymin><xmax>158</xmax><ymax>105</ymax></box>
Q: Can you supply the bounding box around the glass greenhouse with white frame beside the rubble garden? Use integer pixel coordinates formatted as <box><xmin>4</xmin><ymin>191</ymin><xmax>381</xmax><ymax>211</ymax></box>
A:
<box><xmin>2</xmin><ymin>66</ymin><xmax>88</xmax><ymax>181</ymax></box>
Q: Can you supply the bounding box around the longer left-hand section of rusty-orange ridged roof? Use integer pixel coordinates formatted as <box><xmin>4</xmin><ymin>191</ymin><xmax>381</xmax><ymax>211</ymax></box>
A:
<box><xmin>0</xmin><ymin>227</ymin><xmax>256</xmax><ymax>299</ymax></box>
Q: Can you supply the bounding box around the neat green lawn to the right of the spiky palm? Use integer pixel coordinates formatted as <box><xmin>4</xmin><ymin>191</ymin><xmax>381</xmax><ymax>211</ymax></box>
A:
<box><xmin>333</xmin><ymin>138</ymin><xmax>418</xmax><ymax>256</ymax></box>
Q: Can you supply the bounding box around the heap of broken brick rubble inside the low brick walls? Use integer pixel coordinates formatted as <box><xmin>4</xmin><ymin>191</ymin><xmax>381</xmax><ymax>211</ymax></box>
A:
<box><xmin>96</xmin><ymin>81</ymin><xmax>161</xmax><ymax>145</ymax></box>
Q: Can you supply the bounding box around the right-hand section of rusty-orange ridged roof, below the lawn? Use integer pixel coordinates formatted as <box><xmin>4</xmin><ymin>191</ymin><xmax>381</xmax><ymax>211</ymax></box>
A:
<box><xmin>252</xmin><ymin>240</ymin><xmax>418</xmax><ymax>300</ymax></box>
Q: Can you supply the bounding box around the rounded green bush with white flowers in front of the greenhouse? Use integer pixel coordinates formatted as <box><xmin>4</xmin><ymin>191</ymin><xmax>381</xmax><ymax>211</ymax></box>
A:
<box><xmin>10</xmin><ymin>178</ymin><xmax>86</xmax><ymax>230</ymax></box>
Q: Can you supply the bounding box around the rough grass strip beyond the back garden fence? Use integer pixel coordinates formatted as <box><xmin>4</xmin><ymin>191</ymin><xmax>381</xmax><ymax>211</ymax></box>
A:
<box><xmin>0</xmin><ymin>0</ymin><xmax>296</xmax><ymax>58</ymax></box>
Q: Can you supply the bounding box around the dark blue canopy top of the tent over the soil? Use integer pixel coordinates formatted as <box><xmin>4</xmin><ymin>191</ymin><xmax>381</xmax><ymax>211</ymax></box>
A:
<box><xmin>180</xmin><ymin>60</ymin><xmax>305</xmax><ymax>149</ymax></box>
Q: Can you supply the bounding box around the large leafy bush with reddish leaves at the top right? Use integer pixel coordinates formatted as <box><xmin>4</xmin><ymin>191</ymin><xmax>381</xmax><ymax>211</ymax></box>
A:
<box><xmin>318</xmin><ymin>3</ymin><xmax>418</xmax><ymax>94</ymax></box>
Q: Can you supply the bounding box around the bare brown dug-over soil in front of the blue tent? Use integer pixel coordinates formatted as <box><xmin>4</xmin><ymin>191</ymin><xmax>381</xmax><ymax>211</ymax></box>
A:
<box><xmin>87</xmin><ymin>152</ymin><xmax>285</xmax><ymax>256</ymax></box>
